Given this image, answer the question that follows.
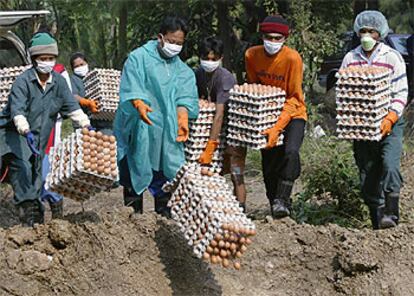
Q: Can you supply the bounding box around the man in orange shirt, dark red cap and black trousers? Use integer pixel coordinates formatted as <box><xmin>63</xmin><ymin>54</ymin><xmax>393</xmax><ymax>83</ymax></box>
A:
<box><xmin>245</xmin><ymin>15</ymin><xmax>307</xmax><ymax>218</ymax></box>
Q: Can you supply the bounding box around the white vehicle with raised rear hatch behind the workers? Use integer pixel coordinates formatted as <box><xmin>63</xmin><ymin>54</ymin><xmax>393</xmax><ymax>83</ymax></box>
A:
<box><xmin>0</xmin><ymin>10</ymin><xmax>50</xmax><ymax>69</ymax></box>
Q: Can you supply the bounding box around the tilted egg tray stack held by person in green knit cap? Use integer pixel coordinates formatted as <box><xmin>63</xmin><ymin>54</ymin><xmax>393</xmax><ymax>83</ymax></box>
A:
<box><xmin>46</xmin><ymin>129</ymin><xmax>118</xmax><ymax>201</ymax></box>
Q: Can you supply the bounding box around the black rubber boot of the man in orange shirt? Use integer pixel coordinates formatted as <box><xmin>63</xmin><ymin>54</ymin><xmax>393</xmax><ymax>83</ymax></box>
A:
<box><xmin>270</xmin><ymin>180</ymin><xmax>293</xmax><ymax>219</ymax></box>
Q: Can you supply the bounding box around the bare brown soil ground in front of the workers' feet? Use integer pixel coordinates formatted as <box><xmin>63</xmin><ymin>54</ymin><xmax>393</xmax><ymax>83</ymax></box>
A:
<box><xmin>0</xmin><ymin>156</ymin><xmax>414</xmax><ymax>296</ymax></box>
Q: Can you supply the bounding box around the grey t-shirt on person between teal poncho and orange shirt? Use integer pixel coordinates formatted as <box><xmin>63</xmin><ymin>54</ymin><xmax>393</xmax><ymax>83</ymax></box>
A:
<box><xmin>195</xmin><ymin>67</ymin><xmax>236</xmax><ymax>104</ymax></box>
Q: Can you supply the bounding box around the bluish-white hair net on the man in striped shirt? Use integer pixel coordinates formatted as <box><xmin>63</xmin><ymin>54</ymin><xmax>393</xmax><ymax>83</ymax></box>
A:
<box><xmin>354</xmin><ymin>10</ymin><xmax>389</xmax><ymax>38</ymax></box>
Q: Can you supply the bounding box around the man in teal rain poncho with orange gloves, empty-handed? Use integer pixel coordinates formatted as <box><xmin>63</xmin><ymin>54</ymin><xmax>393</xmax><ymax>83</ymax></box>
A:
<box><xmin>114</xmin><ymin>17</ymin><xmax>198</xmax><ymax>216</ymax></box>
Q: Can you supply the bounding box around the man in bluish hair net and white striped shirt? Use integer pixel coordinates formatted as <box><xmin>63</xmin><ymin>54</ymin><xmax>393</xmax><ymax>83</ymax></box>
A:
<box><xmin>341</xmin><ymin>10</ymin><xmax>408</xmax><ymax>229</ymax></box>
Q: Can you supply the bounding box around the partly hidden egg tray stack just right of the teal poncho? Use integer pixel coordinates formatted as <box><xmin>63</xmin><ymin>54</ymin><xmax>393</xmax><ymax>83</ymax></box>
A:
<box><xmin>185</xmin><ymin>100</ymin><xmax>226</xmax><ymax>172</ymax></box>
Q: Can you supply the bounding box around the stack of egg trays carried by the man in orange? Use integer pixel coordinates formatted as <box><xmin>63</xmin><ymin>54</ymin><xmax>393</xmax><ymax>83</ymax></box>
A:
<box><xmin>227</xmin><ymin>83</ymin><xmax>286</xmax><ymax>150</ymax></box>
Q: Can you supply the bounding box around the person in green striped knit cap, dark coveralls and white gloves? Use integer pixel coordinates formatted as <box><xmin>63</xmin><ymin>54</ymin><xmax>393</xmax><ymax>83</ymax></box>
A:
<box><xmin>0</xmin><ymin>33</ymin><xmax>90</xmax><ymax>226</ymax></box>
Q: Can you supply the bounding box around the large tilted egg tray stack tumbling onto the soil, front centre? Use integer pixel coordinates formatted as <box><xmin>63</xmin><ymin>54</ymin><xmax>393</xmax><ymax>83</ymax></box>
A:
<box><xmin>163</xmin><ymin>163</ymin><xmax>256</xmax><ymax>269</ymax></box>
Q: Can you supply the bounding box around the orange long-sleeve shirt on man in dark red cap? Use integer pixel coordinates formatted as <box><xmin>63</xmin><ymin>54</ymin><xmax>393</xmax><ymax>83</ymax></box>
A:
<box><xmin>245</xmin><ymin>45</ymin><xmax>308</xmax><ymax>120</ymax></box>
